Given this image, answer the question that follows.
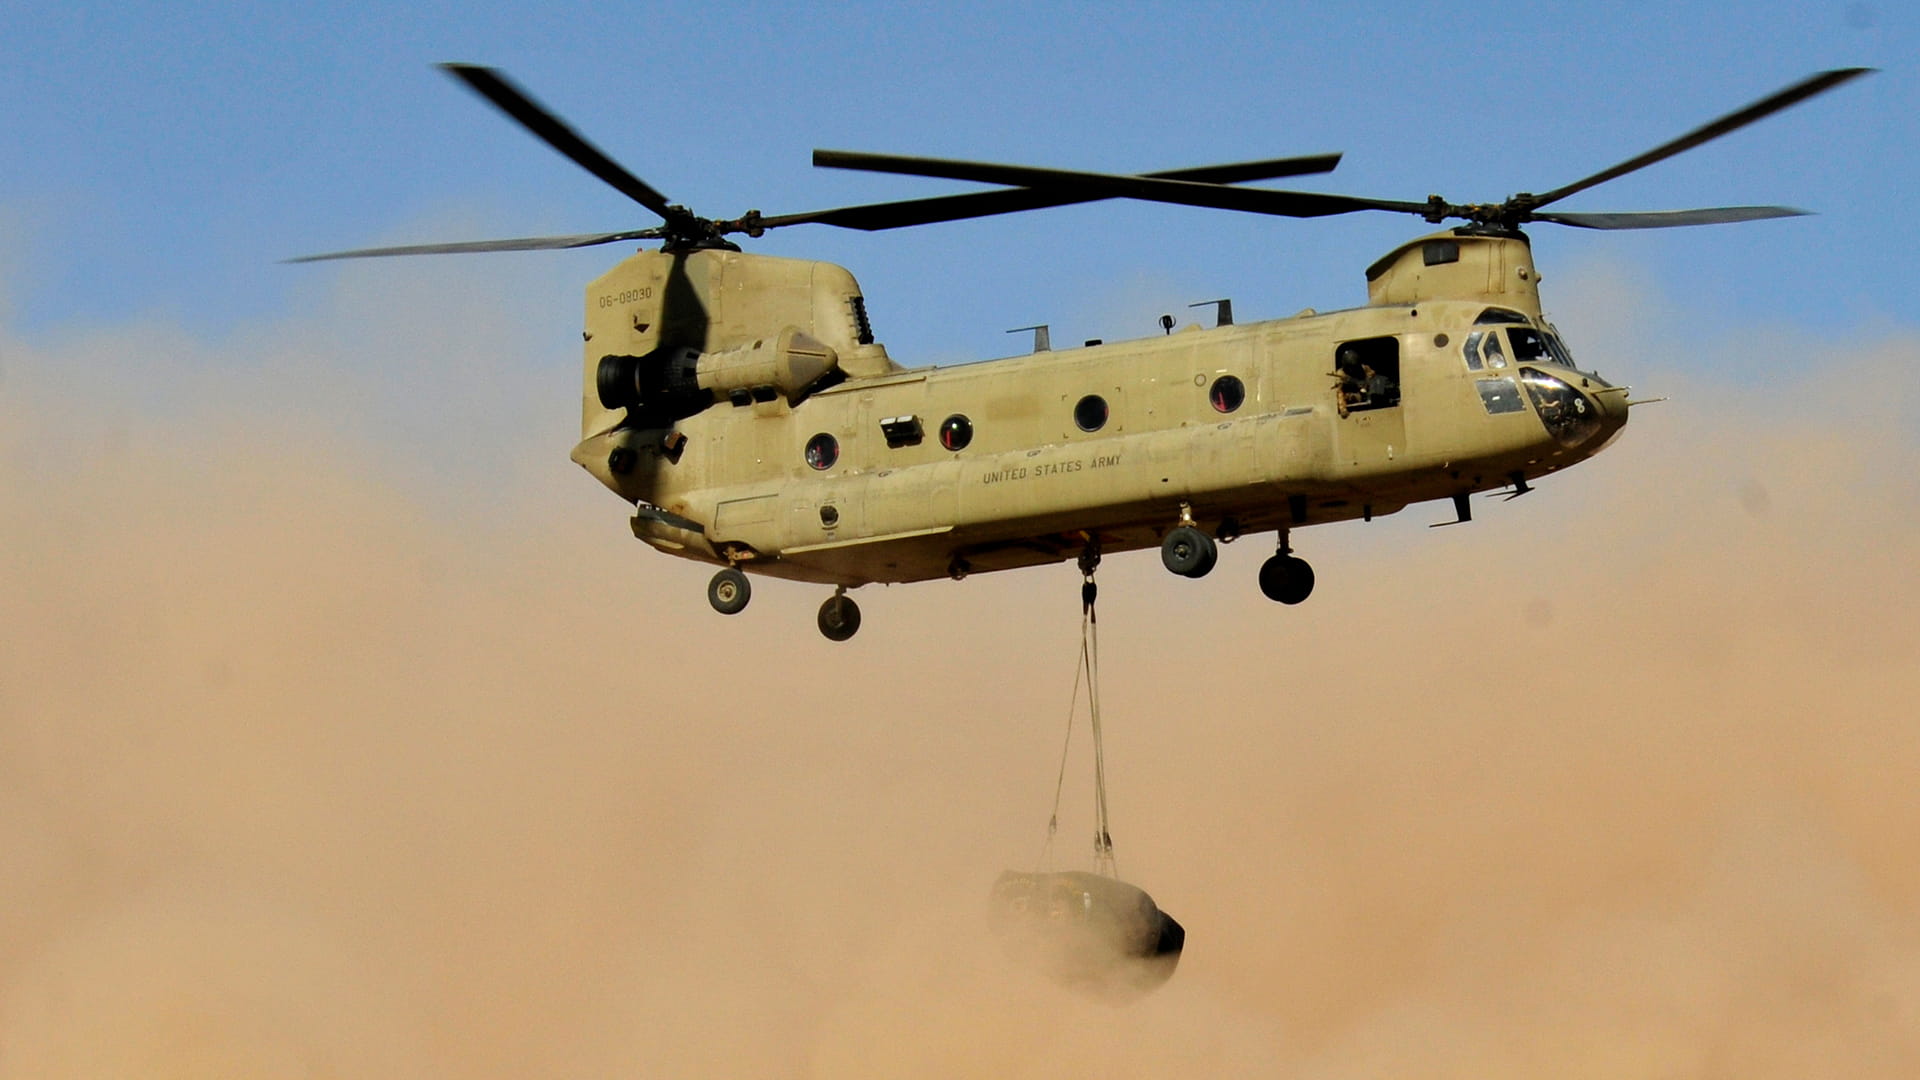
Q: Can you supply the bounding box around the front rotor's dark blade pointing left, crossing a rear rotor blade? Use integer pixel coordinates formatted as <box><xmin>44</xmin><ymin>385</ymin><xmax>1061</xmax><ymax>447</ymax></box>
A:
<box><xmin>814</xmin><ymin>150</ymin><xmax>1428</xmax><ymax>217</ymax></box>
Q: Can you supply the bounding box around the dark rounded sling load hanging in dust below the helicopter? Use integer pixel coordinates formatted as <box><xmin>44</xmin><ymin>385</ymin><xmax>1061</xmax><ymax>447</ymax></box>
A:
<box><xmin>989</xmin><ymin>871</ymin><xmax>1187</xmax><ymax>1001</ymax></box>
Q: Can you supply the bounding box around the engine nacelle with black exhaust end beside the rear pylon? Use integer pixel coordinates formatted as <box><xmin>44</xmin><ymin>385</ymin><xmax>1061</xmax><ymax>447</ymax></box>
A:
<box><xmin>595</xmin><ymin>327</ymin><xmax>841</xmax><ymax>427</ymax></box>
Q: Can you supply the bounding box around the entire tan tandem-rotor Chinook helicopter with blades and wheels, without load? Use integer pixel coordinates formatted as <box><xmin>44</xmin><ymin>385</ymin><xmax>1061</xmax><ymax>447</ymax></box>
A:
<box><xmin>296</xmin><ymin>65</ymin><xmax>1868</xmax><ymax>640</ymax></box>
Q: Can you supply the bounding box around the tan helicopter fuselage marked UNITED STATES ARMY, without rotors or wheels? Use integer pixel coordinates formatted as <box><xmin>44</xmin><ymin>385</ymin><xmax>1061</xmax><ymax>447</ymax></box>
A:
<box><xmin>572</xmin><ymin>231</ymin><xmax>1626</xmax><ymax>586</ymax></box>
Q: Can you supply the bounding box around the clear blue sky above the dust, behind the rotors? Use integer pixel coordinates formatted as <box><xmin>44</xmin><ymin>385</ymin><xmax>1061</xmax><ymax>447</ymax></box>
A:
<box><xmin>0</xmin><ymin>2</ymin><xmax>1920</xmax><ymax>365</ymax></box>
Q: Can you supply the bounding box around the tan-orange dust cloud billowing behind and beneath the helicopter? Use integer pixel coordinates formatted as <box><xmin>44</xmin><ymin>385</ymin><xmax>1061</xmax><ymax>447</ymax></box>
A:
<box><xmin>0</xmin><ymin>278</ymin><xmax>1920</xmax><ymax>1080</ymax></box>
